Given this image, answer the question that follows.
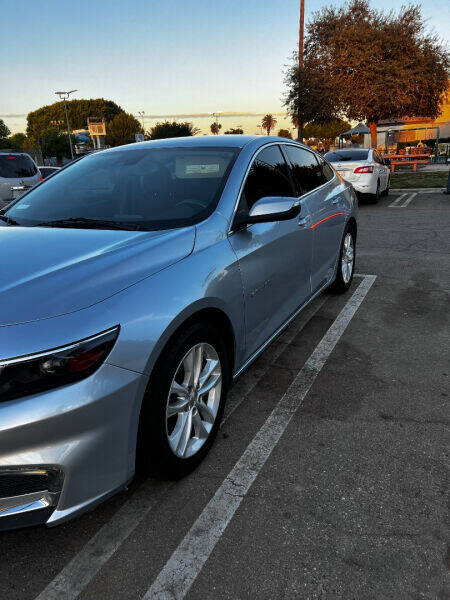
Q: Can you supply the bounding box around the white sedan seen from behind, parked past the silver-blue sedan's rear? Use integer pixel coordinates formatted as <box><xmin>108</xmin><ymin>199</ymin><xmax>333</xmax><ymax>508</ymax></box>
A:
<box><xmin>324</xmin><ymin>148</ymin><xmax>390</xmax><ymax>204</ymax></box>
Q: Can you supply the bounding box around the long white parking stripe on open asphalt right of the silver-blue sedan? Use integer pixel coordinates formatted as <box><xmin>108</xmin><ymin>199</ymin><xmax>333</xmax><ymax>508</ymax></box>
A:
<box><xmin>143</xmin><ymin>275</ymin><xmax>376</xmax><ymax>600</ymax></box>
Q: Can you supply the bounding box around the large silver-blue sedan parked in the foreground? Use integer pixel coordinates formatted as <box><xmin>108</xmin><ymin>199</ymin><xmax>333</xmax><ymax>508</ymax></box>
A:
<box><xmin>0</xmin><ymin>135</ymin><xmax>357</xmax><ymax>529</ymax></box>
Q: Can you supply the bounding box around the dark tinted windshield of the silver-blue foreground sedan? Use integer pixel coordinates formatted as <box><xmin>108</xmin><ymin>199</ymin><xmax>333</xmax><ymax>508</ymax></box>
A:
<box><xmin>4</xmin><ymin>147</ymin><xmax>239</xmax><ymax>230</ymax></box>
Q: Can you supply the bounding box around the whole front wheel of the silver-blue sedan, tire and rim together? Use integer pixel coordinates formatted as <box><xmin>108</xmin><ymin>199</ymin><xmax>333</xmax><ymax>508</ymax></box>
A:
<box><xmin>137</xmin><ymin>323</ymin><xmax>228</xmax><ymax>479</ymax></box>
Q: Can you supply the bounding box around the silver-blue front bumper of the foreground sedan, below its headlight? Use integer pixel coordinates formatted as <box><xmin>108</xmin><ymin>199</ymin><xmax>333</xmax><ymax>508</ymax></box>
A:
<box><xmin>0</xmin><ymin>363</ymin><xmax>147</xmax><ymax>530</ymax></box>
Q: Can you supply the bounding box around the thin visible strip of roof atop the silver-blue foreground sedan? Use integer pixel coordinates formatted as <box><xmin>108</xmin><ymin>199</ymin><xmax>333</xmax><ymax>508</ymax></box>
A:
<box><xmin>103</xmin><ymin>135</ymin><xmax>304</xmax><ymax>152</ymax></box>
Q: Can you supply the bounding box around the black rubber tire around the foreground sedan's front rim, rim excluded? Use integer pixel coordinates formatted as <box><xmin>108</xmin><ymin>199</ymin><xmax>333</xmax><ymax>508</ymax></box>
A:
<box><xmin>136</xmin><ymin>322</ymin><xmax>230</xmax><ymax>480</ymax></box>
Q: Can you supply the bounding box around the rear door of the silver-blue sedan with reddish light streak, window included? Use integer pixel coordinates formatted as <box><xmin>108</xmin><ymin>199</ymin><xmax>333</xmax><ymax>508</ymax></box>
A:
<box><xmin>285</xmin><ymin>144</ymin><xmax>346</xmax><ymax>293</ymax></box>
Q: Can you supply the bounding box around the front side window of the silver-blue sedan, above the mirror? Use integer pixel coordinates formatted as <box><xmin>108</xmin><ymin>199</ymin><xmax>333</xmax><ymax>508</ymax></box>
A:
<box><xmin>241</xmin><ymin>146</ymin><xmax>294</xmax><ymax>210</ymax></box>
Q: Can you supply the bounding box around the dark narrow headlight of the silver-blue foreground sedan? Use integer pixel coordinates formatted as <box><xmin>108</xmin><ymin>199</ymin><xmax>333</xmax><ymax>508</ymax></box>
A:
<box><xmin>0</xmin><ymin>325</ymin><xmax>119</xmax><ymax>401</ymax></box>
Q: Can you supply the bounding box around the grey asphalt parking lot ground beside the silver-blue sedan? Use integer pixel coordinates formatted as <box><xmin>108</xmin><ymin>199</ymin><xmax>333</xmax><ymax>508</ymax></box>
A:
<box><xmin>0</xmin><ymin>192</ymin><xmax>450</xmax><ymax>600</ymax></box>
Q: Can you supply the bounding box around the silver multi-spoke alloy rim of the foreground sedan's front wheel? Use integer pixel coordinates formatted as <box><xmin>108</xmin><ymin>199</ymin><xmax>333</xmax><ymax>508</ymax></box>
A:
<box><xmin>166</xmin><ymin>343</ymin><xmax>222</xmax><ymax>458</ymax></box>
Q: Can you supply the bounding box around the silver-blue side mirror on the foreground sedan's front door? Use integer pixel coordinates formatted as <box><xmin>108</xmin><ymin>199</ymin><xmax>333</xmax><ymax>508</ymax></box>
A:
<box><xmin>234</xmin><ymin>196</ymin><xmax>300</xmax><ymax>229</ymax></box>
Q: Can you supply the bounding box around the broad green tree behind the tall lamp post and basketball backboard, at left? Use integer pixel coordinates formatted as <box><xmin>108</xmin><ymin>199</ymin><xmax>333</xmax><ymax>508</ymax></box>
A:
<box><xmin>27</xmin><ymin>98</ymin><xmax>124</xmax><ymax>138</ymax></box>
